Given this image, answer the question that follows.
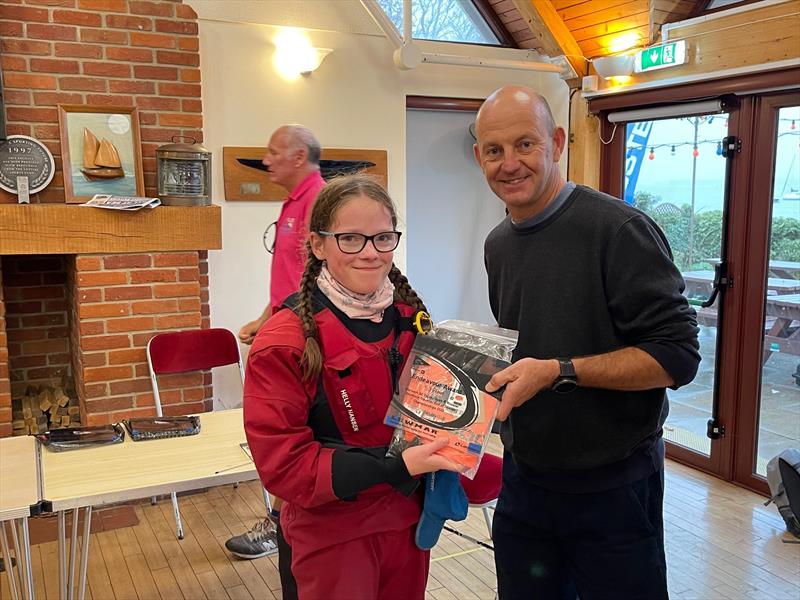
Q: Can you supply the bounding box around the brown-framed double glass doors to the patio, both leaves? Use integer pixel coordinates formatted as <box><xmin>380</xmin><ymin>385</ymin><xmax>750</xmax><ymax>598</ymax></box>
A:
<box><xmin>601</xmin><ymin>86</ymin><xmax>800</xmax><ymax>493</ymax></box>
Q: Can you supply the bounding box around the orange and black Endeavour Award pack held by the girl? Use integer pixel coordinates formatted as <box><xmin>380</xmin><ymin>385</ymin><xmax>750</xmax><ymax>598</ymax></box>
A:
<box><xmin>384</xmin><ymin>335</ymin><xmax>509</xmax><ymax>479</ymax></box>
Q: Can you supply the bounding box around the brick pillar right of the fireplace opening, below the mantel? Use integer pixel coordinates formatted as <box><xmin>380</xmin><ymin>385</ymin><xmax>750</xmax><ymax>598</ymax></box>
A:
<box><xmin>73</xmin><ymin>252</ymin><xmax>211</xmax><ymax>425</ymax></box>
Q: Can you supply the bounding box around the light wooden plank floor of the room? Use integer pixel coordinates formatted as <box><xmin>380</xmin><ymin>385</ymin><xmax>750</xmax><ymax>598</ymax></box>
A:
<box><xmin>0</xmin><ymin>462</ymin><xmax>800</xmax><ymax>600</ymax></box>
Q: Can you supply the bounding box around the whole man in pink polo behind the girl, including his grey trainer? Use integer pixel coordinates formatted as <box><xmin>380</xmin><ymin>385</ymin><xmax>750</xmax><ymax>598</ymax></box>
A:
<box><xmin>225</xmin><ymin>125</ymin><xmax>325</xmax><ymax>584</ymax></box>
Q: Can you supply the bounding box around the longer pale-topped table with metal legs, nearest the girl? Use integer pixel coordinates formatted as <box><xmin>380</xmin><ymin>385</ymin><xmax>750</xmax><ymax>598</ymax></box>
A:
<box><xmin>41</xmin><ymin>408</ymin><xmax>258</xmax><ymax>600</ymax></box>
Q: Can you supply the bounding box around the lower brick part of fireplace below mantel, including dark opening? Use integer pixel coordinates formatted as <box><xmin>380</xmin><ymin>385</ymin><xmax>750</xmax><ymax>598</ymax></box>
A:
<box><xmin>0</xmin><ymin>252</ymin><xmax>211</xmax><ymax>435</ymax></box>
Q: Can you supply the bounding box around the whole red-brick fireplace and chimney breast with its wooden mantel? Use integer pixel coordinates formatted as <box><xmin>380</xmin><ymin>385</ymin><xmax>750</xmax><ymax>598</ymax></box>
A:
<box><xmin>0</xmin><ymin>0</ymin><xmax>220</xmax><ymax>436</ymax></box>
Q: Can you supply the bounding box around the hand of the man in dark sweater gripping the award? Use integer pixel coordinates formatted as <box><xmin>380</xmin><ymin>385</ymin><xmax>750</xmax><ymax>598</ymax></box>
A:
<box><xmin>486</xmin><ymin>358</ymin><xmax>560</xmax><ymax>421</ymax></box>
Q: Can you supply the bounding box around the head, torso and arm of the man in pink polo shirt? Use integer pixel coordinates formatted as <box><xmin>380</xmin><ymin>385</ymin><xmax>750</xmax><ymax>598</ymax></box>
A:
<box><xmin>239</xmin><ymin>125</ymin><xmax>325</xmax><ymax>344</ymax></box>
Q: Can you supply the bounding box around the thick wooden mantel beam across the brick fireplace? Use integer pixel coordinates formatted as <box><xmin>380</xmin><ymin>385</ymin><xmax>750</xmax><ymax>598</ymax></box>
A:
<box><xmin>0</xmin><ymin>204</ymin><xmax>222</xmax><ymax>255</ymax></box>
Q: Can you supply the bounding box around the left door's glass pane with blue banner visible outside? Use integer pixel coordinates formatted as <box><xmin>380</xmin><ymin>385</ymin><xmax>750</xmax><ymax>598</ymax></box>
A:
<box><xmin>624</xmin><ymin>113</ymin><xmax>729</xmax><ymax>468</ymax></box>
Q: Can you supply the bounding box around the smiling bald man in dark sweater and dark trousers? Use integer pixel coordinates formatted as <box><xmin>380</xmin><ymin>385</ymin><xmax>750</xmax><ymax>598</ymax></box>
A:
<box><xmin>475</xmin><ymin>86</ymin><xmax>700</xmax><ymax>600</ymax></box>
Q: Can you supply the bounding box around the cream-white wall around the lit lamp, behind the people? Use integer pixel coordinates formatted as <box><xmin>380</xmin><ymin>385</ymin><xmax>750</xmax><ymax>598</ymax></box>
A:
<box><xmin>189</xmin><ymin>0</ymin><xmax>568</xmax><ymax>406</ymax></box>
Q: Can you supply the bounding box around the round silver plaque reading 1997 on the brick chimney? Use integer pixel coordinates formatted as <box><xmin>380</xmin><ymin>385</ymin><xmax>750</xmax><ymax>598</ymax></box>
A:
<box><xmin>0</xmin><ymin>135</ymin><xmax>56</xmax><ymax>204</ymax></box>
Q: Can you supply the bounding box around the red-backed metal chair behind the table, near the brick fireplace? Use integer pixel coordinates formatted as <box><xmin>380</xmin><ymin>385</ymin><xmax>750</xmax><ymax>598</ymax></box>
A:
<box><xmin>147</xmin><ymin>328</ymin><xmax>244</xmax><ymax>540</ymax></box>
